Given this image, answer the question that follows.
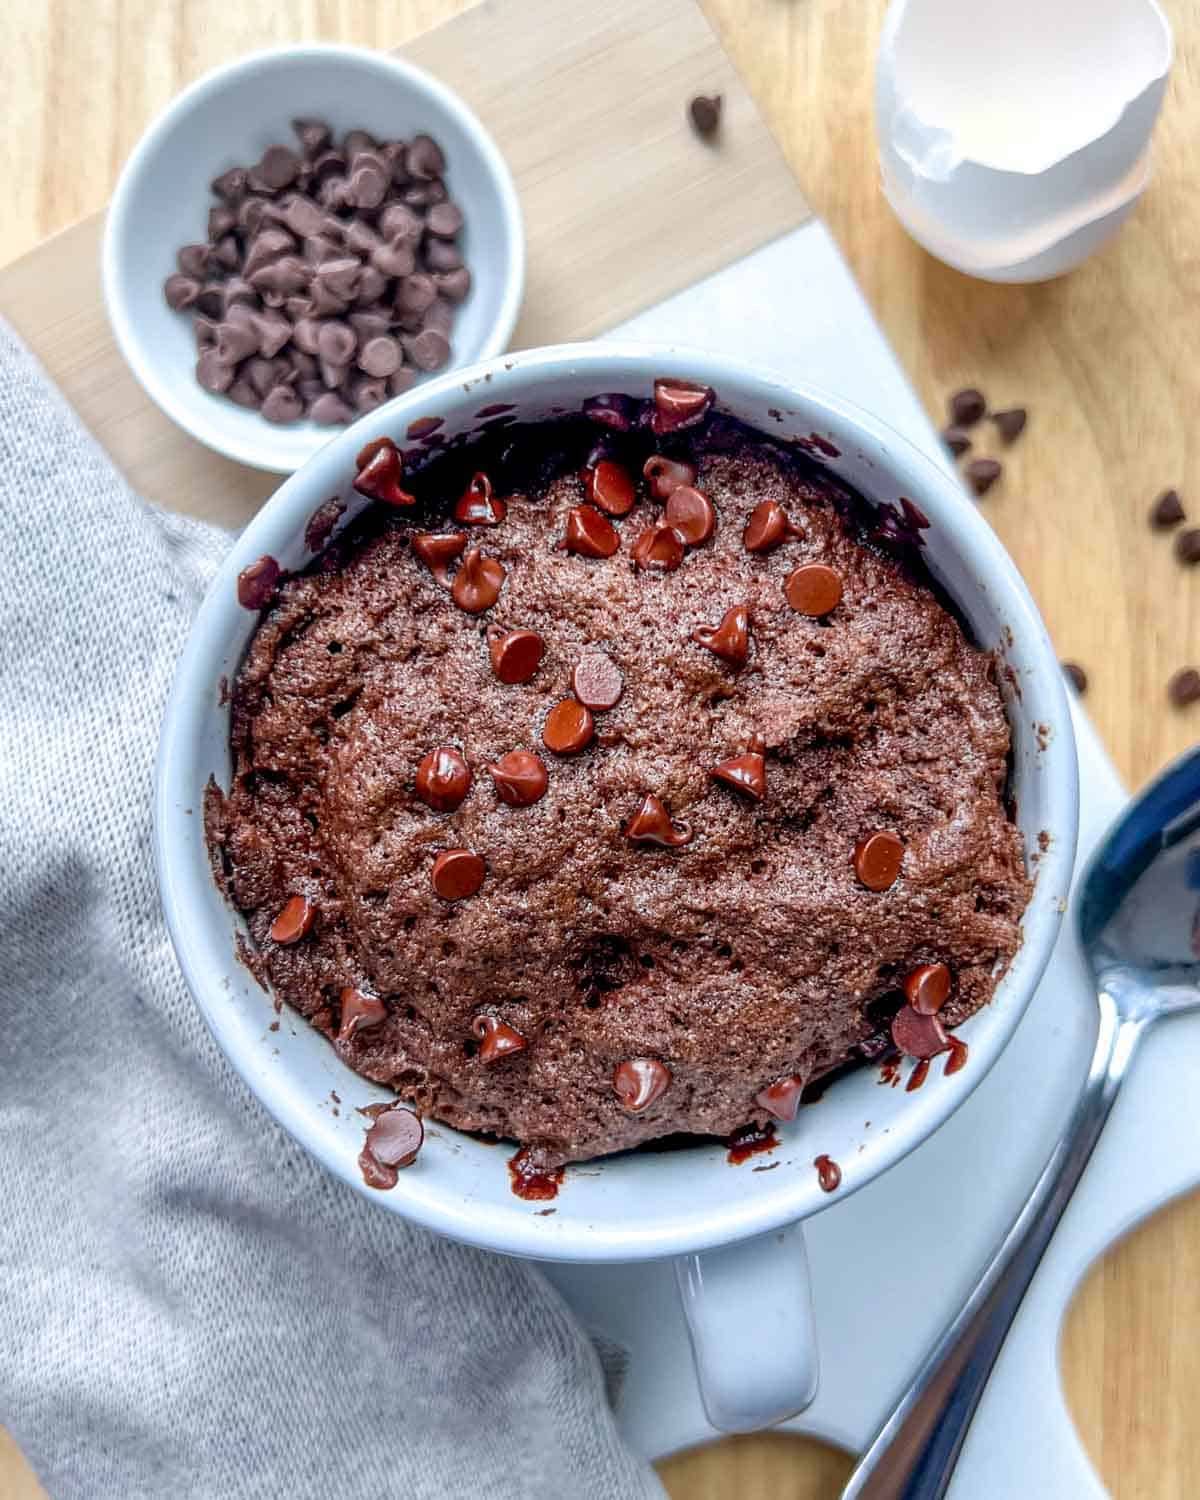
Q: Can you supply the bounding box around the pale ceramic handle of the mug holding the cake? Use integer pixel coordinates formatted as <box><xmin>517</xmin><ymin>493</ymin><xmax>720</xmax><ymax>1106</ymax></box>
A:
<box><xmin>675</xmin><ymin>1224</ymin><xmax>819</xmax><ymax>1433</ymax></box>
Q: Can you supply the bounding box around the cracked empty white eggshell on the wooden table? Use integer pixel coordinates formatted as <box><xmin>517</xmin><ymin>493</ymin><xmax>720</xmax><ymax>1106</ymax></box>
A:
<box><xmin>876</xmin><ymin>0</ymin><xmax>1172</xmax><ymax>281</ymax></box>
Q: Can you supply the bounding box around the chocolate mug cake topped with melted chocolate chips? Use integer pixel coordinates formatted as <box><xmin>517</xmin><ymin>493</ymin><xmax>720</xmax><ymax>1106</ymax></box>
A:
<box><xmin>206</xmin><ymin>380</ymin><xmax>1031</xmax><ymax>1181</ymax></box>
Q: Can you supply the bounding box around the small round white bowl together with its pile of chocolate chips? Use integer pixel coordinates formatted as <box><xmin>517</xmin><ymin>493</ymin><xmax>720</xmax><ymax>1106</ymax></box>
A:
<box><xmin>102</xmin><ymin>45</ymin><xmax>525</xmax><ymax>473</ymax></box>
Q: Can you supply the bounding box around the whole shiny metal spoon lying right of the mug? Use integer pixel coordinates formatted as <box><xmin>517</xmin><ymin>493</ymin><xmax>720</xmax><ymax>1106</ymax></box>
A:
<box><xmin>843</xmin><ymin>747</ymin><xmax>1200</xmax><ymax>1500</ymax></box>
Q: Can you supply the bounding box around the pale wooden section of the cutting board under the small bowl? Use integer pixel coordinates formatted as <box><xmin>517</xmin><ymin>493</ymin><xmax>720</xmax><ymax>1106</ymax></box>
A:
<box><xmin>0</xmin><ymin>0</ymin><xmax>810</xmax><ymax>525</ymax></box>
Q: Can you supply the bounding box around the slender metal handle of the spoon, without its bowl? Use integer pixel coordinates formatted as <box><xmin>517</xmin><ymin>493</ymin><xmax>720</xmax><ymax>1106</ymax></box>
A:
<box><xmin>842</xmin><ymin>992</ymin><xmax>1146</xmax><ymax>1500</ymax></box>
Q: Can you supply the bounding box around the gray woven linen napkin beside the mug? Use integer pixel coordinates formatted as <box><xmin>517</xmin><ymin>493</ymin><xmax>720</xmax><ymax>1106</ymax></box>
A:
<box><xmin>0</xmin><ymin>324</ymin><xmax>663</xmax><ymax>1500</ymax></box>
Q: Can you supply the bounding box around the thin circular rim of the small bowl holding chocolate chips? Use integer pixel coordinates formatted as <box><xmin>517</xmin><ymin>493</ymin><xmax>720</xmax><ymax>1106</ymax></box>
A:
<box><xmin>101</xmin><ymin>42</ymin><xmax>525</xmax><ymax>474</ymax></box>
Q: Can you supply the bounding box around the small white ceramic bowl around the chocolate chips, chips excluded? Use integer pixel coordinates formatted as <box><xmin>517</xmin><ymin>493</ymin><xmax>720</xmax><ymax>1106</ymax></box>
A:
<box><xmin>102</xmin><ymin>47</ymin><xmax>525</xmax><ymax>474</ymax></box>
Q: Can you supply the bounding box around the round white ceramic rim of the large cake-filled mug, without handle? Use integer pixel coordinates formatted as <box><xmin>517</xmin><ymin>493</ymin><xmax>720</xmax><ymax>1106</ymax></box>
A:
<box><xmin>155</xmin><ymin>342</ymin><xmax>1079</xmax><ymax>1263</ymax></box>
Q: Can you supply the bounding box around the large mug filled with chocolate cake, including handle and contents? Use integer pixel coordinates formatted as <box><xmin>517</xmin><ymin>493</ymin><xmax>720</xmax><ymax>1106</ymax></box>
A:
<box><xmin>156</xmin><ymin>344</ymin><xmax>1076</xmax><ymax>1427</ymax></box>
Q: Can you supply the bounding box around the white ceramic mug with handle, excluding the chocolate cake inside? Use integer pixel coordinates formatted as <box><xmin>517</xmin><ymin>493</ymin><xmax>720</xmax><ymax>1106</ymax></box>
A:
<box><xmin>155</xmin><ymin>342</ymin><xmax>1077</xmax><ymax>1431</ymax></box>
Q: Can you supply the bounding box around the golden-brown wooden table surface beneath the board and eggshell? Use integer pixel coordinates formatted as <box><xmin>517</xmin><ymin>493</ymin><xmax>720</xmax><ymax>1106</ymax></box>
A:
<box><xmin>0</xmin><ymin>0</ymin><xmax>1200</xmax><ymax>1500</ymax></box>
